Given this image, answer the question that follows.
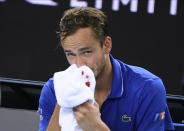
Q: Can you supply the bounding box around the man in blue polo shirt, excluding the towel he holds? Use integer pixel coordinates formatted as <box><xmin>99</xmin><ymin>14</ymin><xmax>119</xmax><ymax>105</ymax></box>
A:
<box><xmin>39</xmin><ymin>8</ymin><xmax>173</xmax><ymax>131</ymax></box>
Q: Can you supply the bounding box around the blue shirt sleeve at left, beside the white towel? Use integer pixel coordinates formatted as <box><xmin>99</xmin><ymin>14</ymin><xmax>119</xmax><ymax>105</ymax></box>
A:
<box><xmin>38</xmin><ymin>78</ymin><xmax>56</xmax><ymax>131</ymax></box>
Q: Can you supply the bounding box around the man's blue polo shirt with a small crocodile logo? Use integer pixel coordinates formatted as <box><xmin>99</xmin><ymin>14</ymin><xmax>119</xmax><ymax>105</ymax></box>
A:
<box><xmin>39</xmin><ymin>55</ymin><xmax>174</xmax><ymax>131</ymax></box>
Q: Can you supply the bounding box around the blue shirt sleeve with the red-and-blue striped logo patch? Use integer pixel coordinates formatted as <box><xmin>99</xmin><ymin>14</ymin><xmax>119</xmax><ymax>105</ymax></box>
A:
<box><xmin>136</xmin><ymin>78</ymin><xmax>174</xmax><ymax>131</ymax></box>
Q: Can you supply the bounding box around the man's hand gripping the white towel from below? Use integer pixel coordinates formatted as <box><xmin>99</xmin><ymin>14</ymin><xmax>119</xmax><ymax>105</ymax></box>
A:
<box><xmin>73</xmin><ymin>102</ymin><xmax>110</xmax><ymax>131</ymax></box>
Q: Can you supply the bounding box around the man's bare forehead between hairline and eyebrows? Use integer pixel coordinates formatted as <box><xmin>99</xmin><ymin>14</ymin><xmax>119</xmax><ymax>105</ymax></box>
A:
<box><xmin>62</xmin><ymin>27</ymin><xmax>100</xmax><ymax>48</ymax></box>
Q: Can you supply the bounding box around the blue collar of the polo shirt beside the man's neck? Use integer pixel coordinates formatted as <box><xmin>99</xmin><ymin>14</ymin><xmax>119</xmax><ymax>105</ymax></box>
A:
<box><xmin>108</xmin><ymin>55</ymin><xmax>123</xmax><ymax>98</ymax></box>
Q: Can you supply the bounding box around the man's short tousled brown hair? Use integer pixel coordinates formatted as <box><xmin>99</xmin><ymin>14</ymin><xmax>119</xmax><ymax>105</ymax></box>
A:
<box><xmin>59</xmin><ymin>7</ymin><xmax>108</xmax><ymax>46</ymax></box>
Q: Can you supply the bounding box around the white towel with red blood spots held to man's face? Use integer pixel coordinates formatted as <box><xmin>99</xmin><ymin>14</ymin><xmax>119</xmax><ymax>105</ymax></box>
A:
<box><xmin>54</xmin><ymin>64</ymin><xmax>96</xmax><ymax>131</ymax></box>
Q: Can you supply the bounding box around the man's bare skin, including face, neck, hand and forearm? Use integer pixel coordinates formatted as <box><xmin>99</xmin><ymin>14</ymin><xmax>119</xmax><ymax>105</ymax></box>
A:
<box><xmin>47</xmin><ymin>27</ymin><xmax>113</xmax><ymax>131</ymax></box>
